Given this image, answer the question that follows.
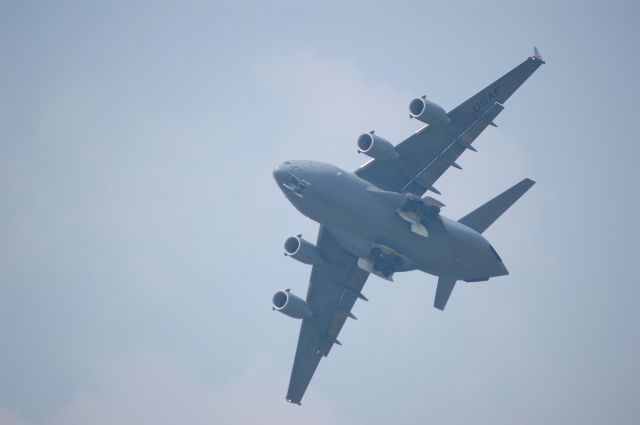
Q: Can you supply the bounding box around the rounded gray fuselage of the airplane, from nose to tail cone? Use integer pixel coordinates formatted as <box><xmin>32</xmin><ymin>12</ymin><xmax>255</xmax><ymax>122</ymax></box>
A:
<box><xmin>273</xmin><ymin>161</ymin><xmax>508</xmax><ymax>281</ymax></box>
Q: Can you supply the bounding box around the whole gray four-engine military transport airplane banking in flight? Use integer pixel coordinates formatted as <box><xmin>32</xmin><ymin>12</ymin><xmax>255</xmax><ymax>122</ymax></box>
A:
<box><xmin>272</xmin><ymin>47</ymin><xmax>545</xmax><ymax>405</ymax></box>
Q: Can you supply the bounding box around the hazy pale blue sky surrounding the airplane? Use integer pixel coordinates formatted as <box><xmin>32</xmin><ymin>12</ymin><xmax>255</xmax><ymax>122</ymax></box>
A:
<box><xmin>0</xmin><ymin>0</ymin><xmax>640</xmax><ymax>425</ymax></box>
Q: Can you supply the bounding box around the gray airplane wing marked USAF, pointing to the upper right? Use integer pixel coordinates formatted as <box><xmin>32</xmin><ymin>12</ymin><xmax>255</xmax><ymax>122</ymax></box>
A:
<box><xmin>356</xmin><ymin>48</ymin><xmax>544</xmax><ymax>196</ymax></box>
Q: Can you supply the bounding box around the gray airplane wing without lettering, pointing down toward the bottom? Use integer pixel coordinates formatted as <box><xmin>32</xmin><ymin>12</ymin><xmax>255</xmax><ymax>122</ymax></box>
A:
<box><xmin>287</xmin><ymin>226</ymin><xmax>369</xmax><ymax>404</ymax></box>
